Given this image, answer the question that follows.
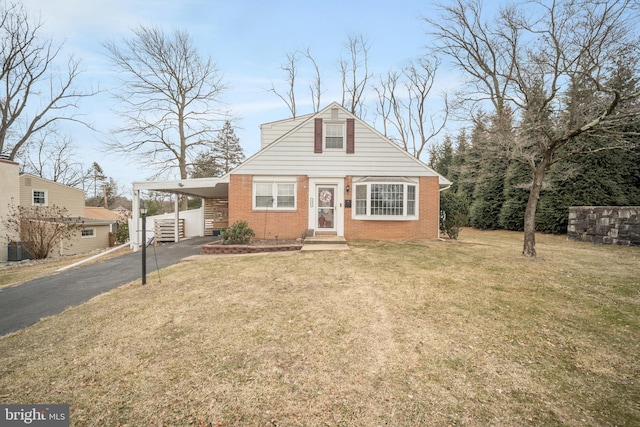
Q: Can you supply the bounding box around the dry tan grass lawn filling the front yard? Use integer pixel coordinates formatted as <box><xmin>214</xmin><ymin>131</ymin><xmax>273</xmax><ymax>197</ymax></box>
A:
<box><xmin>0</xmin><ymin>229</ymin><xmax>640</xmax><ymax>426</ymax></box>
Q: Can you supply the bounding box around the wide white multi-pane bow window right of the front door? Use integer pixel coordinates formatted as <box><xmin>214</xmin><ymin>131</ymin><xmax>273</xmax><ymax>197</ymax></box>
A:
<box><xmin>354</xmin><ymin>182</ymin><xmax>417</xmax><ymax>219</ymax></box>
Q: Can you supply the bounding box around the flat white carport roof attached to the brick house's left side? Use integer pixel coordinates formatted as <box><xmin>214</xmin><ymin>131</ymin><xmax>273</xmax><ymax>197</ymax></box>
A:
<box><xmin>133</xmin><ymin>175</ymin><xmax>229</xmax><ymax>199</ymax></box>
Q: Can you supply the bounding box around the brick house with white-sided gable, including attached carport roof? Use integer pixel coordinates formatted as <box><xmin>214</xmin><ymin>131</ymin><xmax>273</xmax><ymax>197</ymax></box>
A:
<box><xmin>133</xmin><ymin>103</ymin><xmax>451</xmax><ymax>246</ymax></box>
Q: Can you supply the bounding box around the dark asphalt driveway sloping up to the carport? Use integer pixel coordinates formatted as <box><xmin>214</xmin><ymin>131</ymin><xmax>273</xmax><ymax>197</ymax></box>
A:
<box><xmin>0</xmin><ymin>236</ymin><xmax>216</xmax><ymax>336</ymax></box>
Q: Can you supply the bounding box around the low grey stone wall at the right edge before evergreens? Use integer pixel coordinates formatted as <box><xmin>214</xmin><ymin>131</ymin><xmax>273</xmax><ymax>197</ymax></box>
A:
<box><xmin>567</xmin><ymin>206</ymin><xmax>640</xmax><ymax>246</ymax></box>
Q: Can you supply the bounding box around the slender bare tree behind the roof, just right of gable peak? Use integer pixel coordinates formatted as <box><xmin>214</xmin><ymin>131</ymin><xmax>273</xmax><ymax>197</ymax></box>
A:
<box><xmin>339</xmin><ymin>35</ymin><xmax>373</xmax><ymax>117</ymax></box>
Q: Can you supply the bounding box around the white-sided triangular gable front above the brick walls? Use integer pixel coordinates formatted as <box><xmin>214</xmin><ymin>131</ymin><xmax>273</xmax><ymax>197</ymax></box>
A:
<box><xmin>229</xmin><ymin>102</ymin><xmax>451</xmax><ymax>186</ymax></box>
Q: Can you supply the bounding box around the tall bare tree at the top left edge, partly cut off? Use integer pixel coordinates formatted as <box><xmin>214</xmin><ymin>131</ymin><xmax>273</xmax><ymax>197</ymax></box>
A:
<box><xmin>0</xmin><ymin>3</ymin><xmax>94</xmax><ymax>160</ymax></box>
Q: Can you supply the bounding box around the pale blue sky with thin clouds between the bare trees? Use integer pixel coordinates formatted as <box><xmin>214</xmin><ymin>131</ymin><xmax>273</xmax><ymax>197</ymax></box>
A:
<box><xmin>23</xmin><ymin>0</ymin><xmax>457</xmax><ymax>191</ymax></box>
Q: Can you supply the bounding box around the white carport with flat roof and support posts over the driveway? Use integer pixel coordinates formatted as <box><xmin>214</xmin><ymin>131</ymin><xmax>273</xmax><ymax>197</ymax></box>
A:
<box><xmin>131</xmin><ymin>175</ymin><xmax>229</xmax><ymax>251</ymax></box>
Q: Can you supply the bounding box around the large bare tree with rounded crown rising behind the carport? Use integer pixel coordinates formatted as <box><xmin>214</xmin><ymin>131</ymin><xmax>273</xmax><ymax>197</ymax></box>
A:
<box><xmin>104</xmin><ymin>27</ymin><xmax>226</xmax><ymax>209</ymax></box>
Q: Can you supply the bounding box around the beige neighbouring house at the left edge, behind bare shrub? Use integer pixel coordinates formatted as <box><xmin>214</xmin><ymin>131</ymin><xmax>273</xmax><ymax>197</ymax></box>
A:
<box><xmin>0</xmin><ymin>159</ymin><xmax>115</xmax><ymax>261</ymax></box>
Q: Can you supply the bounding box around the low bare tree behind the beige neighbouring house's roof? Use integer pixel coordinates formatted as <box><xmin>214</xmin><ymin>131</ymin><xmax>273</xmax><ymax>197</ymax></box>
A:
<box><xmin>20</xmin><ymin>128</ymin><xmax>84</xmax><ymax>188</ymax></box>
